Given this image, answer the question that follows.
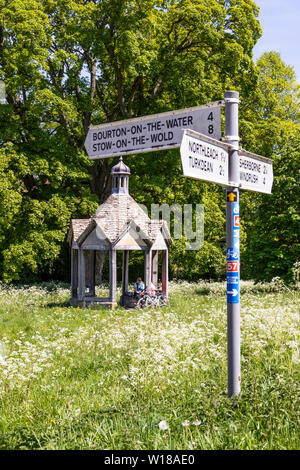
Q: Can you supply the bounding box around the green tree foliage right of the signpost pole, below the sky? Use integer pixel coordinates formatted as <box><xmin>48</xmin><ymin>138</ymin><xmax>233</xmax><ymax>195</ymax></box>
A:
<box><xmin>241</xmin><ymin>52</ymin><xmax>300</xmax><ymax>281</ymax></box>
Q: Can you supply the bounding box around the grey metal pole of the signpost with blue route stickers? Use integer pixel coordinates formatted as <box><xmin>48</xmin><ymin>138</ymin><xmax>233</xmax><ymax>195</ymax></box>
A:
<box><xmin>224</xmin><ymin>91</ymin><xmax>241</xmax><ymax>397</ymax></box>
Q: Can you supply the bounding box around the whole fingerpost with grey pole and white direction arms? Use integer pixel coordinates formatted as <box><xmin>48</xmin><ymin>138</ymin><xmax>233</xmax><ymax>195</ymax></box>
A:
<box><xmin>85</xmin><ymin>91</ymin><xmax>273</xmax><ymax>397</ymax></box>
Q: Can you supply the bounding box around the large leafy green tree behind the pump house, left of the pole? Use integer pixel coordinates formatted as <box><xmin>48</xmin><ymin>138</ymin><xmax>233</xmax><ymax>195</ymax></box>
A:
<box><xmin>0</xmin><ymin>0</ymin><xmax>278</xmax><ymax>281</ymax></box>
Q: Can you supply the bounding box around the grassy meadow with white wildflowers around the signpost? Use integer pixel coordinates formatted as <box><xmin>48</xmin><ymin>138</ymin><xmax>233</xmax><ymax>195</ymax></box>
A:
<box><xmin>0</xmin><ymin>280</ymin><xmax>300</xmax><ymax>450</ymax></box>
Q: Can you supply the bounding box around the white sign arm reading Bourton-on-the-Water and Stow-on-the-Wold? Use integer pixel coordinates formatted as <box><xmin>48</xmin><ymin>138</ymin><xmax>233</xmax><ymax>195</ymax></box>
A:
<box><xmin>85</xmin><ymin>101</ymin><xmax>223</xmax><ymax>158</ymax></box>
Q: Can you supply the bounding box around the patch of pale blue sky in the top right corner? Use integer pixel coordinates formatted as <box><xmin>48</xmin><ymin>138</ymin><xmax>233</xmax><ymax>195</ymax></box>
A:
<box><xmin>253</xmin><ymin>0</ymin><xmax>300</xmax><ymax>81</ymax></box>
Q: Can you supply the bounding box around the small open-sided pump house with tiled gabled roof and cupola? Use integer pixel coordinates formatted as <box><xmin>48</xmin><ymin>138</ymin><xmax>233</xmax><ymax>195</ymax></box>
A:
<box><xmin>68</xmin><ymin>157</ymin><xmax>171</xmax><ymax>307</ymax></box>
